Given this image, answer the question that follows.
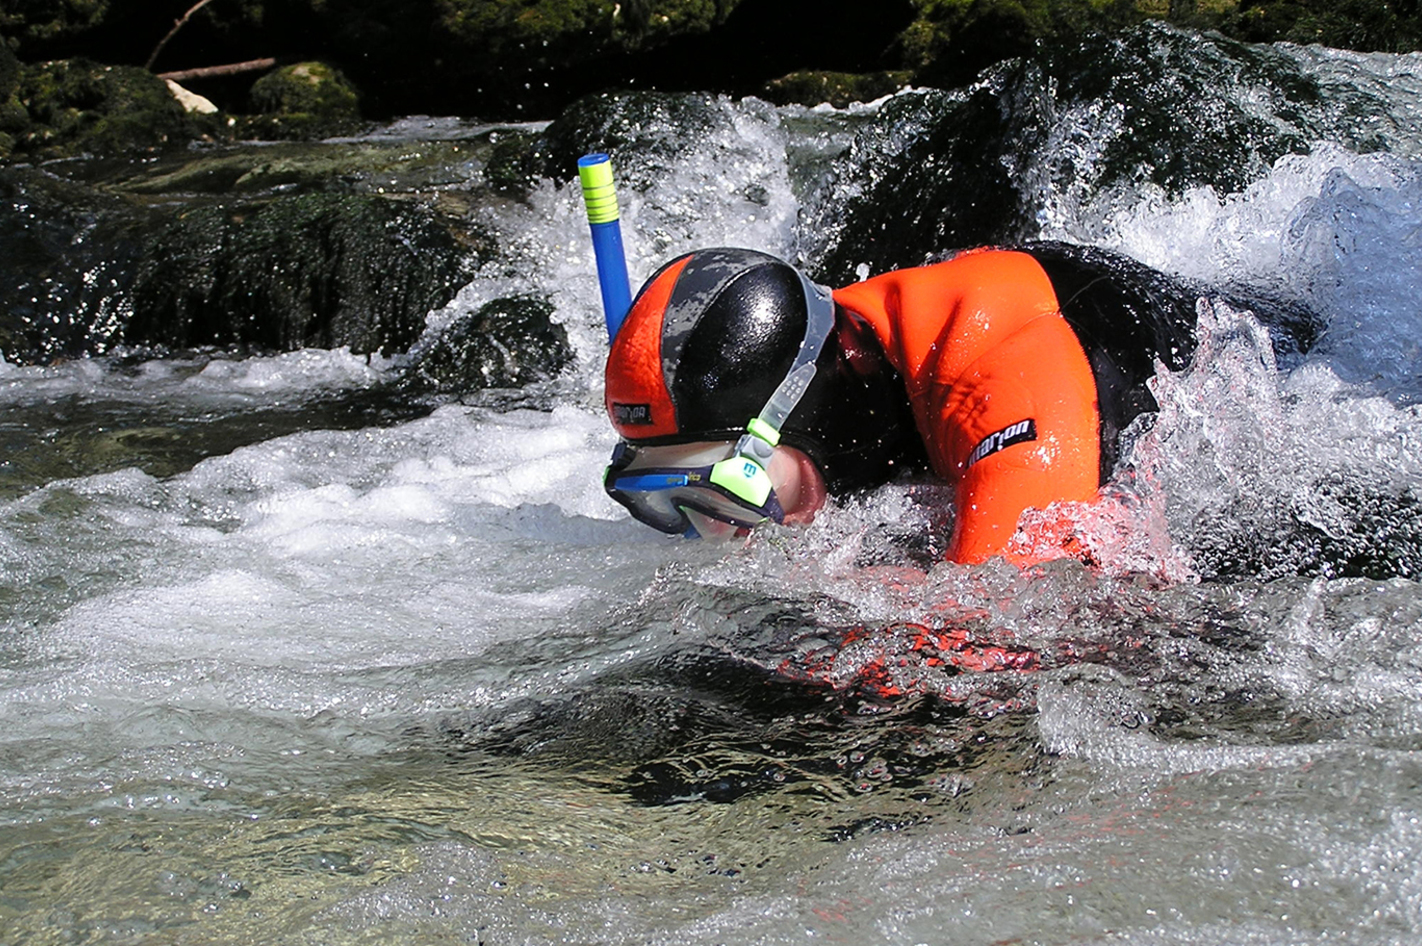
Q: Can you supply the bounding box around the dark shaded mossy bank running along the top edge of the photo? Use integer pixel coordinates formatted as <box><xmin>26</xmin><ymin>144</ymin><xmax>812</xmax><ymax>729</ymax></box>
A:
<box><xmin>0</xmin><ymin>0</ymin><xmax>1422</xmax><ymax>149</ymax></box>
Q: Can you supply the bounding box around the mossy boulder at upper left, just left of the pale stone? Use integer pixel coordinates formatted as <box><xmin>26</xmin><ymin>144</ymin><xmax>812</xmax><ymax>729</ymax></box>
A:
<box><xmin>4</xmin><ymin>58</ymin><xmax>207</xmax><ymax>158</ymax></box>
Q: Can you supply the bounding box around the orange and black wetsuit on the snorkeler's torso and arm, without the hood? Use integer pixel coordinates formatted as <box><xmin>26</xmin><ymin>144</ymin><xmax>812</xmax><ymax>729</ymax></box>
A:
<box><xmin>835</xmin><ymin>249</ymin><xmax>1193</xmax><ymax>562</ymax></box>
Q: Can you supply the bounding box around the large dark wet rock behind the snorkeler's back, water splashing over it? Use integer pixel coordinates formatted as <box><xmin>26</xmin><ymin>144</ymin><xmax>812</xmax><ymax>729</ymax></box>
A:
<box><xmin>803</xmin><ymin>23</ymin><xmax>1389</xmax><ymax>285</ymax></box>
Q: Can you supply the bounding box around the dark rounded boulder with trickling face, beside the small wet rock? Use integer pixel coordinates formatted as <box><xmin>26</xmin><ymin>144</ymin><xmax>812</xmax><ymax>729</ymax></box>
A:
<box><xmin>125</xmin><ymin>193</ymin><xmax>472</xmax><ymax>353</ymax></box>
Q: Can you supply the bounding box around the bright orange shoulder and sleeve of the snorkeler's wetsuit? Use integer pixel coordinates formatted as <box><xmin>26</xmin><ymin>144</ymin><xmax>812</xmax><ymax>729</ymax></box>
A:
<box><xmin>835</xmin><ymin>250</ymin><xmax>1101</xmax><ymax>563</ymax></box>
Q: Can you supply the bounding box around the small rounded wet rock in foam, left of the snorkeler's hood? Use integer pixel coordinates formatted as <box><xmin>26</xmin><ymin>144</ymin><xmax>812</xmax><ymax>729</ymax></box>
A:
<box><xmin>404</xmin><ymin>296</ymin><xmax>573</xmax><ymax>394</ymax></box>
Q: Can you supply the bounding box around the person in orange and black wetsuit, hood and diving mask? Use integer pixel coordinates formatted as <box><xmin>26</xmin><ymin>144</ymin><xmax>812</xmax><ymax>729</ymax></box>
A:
<box><xmin>604</xmin><ymin>243</ymin><xmax>1194</xmax><ymax>562</ymax></box>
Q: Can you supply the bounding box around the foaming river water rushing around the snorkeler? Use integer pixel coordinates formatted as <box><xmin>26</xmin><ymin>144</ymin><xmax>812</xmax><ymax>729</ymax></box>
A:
<box><xmin>0</xmin><ymin>25</ymin><xmax>1422</xmax><ymax>946</ymax></box>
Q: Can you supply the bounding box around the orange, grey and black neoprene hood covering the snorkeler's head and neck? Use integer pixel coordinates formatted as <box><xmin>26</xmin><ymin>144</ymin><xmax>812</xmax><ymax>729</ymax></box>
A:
<box><xmin>606</xmin><ymin>248</ymin><xmax>921</xmax><ymax>492</ymax></box>
